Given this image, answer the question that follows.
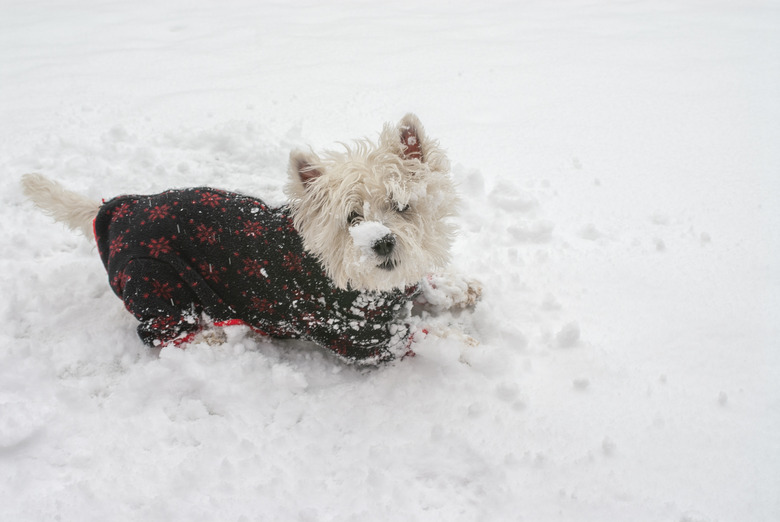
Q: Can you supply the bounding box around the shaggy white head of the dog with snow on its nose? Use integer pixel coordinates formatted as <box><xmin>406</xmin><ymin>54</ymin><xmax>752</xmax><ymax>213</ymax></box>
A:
<box><xmin>286</xmin><ymin>114</ymin><xmax>457</xmax><ymax>290</ymax></box>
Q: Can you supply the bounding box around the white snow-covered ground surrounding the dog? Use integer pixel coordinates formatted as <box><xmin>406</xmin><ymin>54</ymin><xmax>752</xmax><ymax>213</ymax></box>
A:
<box><xmin>0</xmin><ymin>0</ymin><xmax>780</xmax><ymax>522</ymax></box>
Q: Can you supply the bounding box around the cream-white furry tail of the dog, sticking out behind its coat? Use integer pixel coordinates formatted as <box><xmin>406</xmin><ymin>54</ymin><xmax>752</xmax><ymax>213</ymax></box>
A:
<box><xmin>22</xmin><ymin>174</ymin><xmax>101</xmax><ymax>239</ymax></box>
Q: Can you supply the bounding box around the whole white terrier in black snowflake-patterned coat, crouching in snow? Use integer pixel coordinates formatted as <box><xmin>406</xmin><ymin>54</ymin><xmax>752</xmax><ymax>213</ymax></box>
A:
<box><xmin>22</xmin><ymin>114</ymin><xmax>481</xmax><ymax>363</ymax></box>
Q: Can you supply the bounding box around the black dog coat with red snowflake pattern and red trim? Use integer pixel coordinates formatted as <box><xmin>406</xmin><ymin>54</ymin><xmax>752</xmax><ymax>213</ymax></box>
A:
<box><xmin>95</xmin><ymin>188</ymin><xmax>419</xmax><ymax>362</ymax></box>
